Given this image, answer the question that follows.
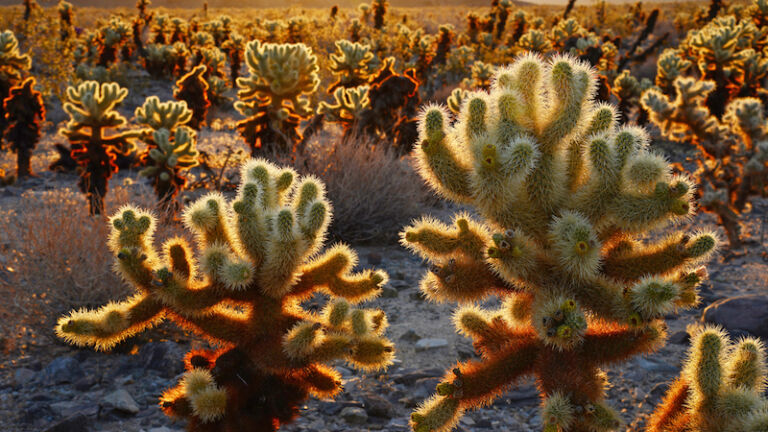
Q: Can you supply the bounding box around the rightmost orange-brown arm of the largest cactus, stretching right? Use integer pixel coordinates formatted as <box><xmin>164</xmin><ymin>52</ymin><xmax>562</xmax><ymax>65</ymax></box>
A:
<box><xmin>603</xmin><ymin>233</ymin><xmax>716</xmax><ymax>281</ymax></box>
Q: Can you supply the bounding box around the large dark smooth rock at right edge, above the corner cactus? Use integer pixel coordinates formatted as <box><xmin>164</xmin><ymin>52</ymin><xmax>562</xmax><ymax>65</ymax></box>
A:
<box><xmin>702</xmin><ymin>295</ymin><xmax>768</xmax><ymax>340</ymax></box>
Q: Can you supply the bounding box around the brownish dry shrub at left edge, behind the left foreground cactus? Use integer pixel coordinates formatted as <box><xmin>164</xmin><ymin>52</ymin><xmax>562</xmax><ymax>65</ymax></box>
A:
<box><xmin>0</xmin><ymin>181</ymin><xmax>181</xmax><ymax>351</ymax></box>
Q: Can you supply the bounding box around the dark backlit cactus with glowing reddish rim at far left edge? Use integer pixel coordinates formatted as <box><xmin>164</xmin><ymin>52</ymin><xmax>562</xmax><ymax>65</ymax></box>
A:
<box><xmin>3</xmin><ymin>77</ymin><xmax>45</xmax><ymax>178</ymax></box>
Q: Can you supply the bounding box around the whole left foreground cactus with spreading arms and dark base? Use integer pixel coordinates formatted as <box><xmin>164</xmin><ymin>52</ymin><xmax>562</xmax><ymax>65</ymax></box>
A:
<box><xmin>56</xmin><ymin>160</ymin><xmax>393</xmax><ymax>432</ymax></box>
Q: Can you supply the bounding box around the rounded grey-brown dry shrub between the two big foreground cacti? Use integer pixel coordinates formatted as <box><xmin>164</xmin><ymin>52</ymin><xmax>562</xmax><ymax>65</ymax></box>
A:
<box><xmin>275</xmin><ymin>132</ymin><xmax>434</xmax><ymax>244</ymax></box>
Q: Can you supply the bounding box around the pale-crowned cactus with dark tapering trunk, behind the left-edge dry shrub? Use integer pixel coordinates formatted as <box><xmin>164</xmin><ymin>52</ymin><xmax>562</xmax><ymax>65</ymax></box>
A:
<box><xmin>59</xmin><ymin>81</ymin><xmax>139</xmax><ymax>214</ymax></box>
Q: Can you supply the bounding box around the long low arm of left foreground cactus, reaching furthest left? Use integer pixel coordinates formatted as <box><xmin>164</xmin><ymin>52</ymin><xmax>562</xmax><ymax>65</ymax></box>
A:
<box><xmin>56</xmin><ymin>295</ymin><xmax>164</xmax><ymax>350</ymax></box>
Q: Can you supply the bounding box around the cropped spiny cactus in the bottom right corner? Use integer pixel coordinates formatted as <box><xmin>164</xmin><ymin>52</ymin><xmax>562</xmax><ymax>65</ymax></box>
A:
<box><xmin>648</xmin><ymin>326</ymin><xmax>768</xmax><ymax>432</ymax></box>
